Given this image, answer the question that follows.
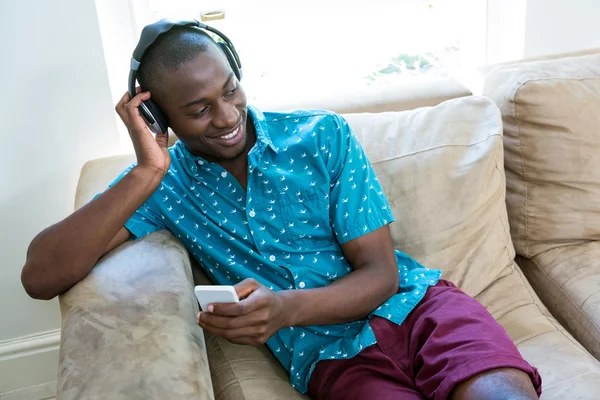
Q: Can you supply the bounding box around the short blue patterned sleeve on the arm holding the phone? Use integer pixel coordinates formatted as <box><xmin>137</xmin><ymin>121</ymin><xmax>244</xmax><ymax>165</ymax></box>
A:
<box><xmin>327</xmin><ymin>115</ymin><xmax>394</xmax><ymax>244</ymax></box>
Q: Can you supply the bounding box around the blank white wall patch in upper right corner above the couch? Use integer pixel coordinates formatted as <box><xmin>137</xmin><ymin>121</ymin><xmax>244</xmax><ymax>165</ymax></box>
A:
<box><xmin>524</xmin><ymin>0</ymin><xmax>600</xmax><ymax>58</ymax></box>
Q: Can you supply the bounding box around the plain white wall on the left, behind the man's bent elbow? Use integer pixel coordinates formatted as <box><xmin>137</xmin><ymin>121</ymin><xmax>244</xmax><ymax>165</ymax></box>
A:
<box><xmin>0</xmin><ymin>0</ymin><xmax>119</xmax><ymax>393</ymax></box>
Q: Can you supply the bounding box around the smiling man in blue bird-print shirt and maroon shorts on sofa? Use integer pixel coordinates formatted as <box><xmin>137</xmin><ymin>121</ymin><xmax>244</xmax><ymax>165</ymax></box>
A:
<box><xmin>22</xmin><ymin>28</ymin><xmax>541</xmax><ymax>399</ymax></box>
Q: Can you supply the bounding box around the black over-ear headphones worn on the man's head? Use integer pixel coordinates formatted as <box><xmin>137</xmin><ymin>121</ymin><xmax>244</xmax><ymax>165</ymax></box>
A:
<box><xmin>129</xmin><ymin>19</ymin><xmax>242</xmax><ymax>134</ymax></box>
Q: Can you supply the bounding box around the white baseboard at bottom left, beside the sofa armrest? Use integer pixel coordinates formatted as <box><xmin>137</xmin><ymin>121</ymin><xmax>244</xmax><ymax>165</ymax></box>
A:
<box><xmin>0</xmin><ymin>329</ymin><xmax>60</xmax><ymax>400</ymax></box>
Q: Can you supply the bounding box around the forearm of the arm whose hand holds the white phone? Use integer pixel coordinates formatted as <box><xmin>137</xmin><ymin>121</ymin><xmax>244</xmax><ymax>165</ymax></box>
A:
<box><xmin>278</xmin><ymin>267</ymin><xmax>398</xmax><ymax>326</ymax></box>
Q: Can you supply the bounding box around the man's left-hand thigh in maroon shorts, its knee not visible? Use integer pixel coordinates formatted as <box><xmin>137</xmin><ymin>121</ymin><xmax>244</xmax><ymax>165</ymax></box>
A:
<box><xmin>308</xmin><ymin>345</ymin><xmax>425</xmax><ymax>400</ymax></box>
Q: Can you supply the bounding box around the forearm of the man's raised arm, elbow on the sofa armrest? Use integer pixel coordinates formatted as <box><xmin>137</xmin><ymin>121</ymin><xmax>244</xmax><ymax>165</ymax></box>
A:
<box><xmin>22</xmin><ymin>167</ymin><xmax>162</xmax><ymax>299</ymax></box>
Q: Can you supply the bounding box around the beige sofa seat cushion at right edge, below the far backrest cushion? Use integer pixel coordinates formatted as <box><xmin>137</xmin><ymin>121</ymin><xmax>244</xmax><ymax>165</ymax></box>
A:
<box><xmin>519</xmin><ymin>241</ymin><xmax>600</xmax><ymax>359</ymax></box>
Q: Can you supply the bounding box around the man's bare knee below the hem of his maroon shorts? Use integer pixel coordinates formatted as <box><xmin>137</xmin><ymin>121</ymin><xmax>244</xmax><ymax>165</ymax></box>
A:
<box><xmin>450</xmin><ymin>368</ymin><xmax>539</xmax><ymax>400</ymax></box>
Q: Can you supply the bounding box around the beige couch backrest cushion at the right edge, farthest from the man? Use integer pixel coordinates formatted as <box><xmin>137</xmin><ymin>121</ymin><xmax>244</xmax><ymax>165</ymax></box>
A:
<box><xmin>485</xmin><ymin>54</ymin><xmax>600</xmax><ymax>258</ymax></box>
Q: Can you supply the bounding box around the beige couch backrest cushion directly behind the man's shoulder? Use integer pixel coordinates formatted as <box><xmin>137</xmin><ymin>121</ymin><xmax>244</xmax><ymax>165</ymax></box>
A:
<box><xmin>344</xmin><ymin>96</ymin><xmax>514</xmax><ymax>295</ymax></box>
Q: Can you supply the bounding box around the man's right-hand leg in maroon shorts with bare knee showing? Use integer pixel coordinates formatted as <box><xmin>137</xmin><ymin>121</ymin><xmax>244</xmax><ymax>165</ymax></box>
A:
<box><xmin>402</xmin><ymin>281</ymin><xmax>541</xmax><ymax>400</ymax></box>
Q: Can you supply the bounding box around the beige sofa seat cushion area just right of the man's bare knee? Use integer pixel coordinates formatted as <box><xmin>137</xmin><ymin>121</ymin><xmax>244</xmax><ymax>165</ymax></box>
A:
<box><xmin>476</xmin><ymin>264</ymin><xmax>600</xmax><ymax>400</ymax></box>
